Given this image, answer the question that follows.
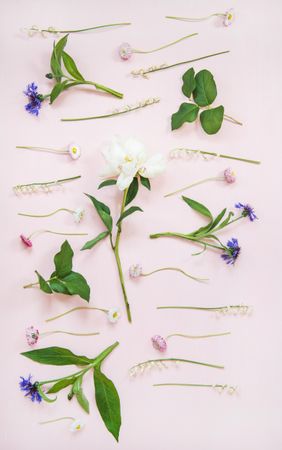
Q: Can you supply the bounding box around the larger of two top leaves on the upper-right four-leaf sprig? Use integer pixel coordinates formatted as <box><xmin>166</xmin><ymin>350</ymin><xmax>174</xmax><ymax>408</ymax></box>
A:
<box><xmin>193</xmin><ymin>70</ymin><xmax>217</xmax><ymax>106</ymax></box>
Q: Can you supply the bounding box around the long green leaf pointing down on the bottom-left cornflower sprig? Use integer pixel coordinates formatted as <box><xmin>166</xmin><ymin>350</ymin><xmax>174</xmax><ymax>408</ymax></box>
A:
<box><xmin>94</xmin><ymin>368</ymin><xmax>121</xmax><ymax>441</ymax></box>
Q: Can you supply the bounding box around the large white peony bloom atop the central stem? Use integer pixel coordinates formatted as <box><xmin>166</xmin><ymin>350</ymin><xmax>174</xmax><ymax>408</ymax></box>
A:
<box><xmin>102</xmin><ymin>138</ymin><xmax>166</xmax><ymax>191</ymax></box>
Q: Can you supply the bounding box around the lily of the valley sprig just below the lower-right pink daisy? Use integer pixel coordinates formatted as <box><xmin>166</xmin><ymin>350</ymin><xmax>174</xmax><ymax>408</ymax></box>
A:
<box><xmin>129</xmin><ymin>358</ymin><xmax>224</xmax><ymax>377</ymax></box>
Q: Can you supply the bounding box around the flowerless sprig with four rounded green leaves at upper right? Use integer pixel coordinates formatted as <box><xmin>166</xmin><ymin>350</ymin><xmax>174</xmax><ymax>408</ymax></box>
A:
<box><xmin>171</xmin><ymin>68</ymin><xmax>242</xmax><ymax>134</ymax></box>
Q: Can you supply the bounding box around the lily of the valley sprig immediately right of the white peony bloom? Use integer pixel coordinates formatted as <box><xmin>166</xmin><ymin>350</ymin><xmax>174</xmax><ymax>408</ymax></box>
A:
<box><xmin>169</xmin><ymin>148</ymin><xmax>261</xmax><ymax>164</ymax></box>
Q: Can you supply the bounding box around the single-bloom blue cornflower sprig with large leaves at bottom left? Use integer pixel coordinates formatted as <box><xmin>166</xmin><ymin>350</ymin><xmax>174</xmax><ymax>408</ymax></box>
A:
<box><xmin>20</xmin><ymin>342</ymin><xmax>121</xmax><ymax>441</ymax></box>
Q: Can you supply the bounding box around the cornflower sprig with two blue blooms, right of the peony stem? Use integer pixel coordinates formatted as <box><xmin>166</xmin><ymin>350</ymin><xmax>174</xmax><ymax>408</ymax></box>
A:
<box><xmin>150</xmin><ymin>196</ymin><xmax>257</xmax><ymax>265</ymax></box>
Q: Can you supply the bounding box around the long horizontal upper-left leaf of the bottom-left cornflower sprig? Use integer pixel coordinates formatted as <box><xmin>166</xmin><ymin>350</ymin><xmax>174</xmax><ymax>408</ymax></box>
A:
<box><xmin>21</xmin><ymin>347</ymin><xmax>93</xmax><ymax>366</ymax></box>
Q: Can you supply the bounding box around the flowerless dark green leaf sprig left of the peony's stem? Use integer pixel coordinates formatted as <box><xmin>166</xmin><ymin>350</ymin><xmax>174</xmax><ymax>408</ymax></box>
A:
<box><xmin>24</xmin><ymin>241</ymin><xmax>90</xmax><ymax>302</ymax></box>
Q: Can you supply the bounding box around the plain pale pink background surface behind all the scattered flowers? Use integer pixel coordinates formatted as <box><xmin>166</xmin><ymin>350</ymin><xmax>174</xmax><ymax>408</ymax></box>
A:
<box><xmin>0</xmin><ymin>0</ymin><xmax>282</xmax><ymax>450</ymax></box>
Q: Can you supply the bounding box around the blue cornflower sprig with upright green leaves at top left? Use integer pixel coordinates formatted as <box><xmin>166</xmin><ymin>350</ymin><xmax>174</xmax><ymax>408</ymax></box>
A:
<box><xmin>24</xmin><ymin>35</ymin><xmax>123</xmax><ymax>116</ymax></box>
